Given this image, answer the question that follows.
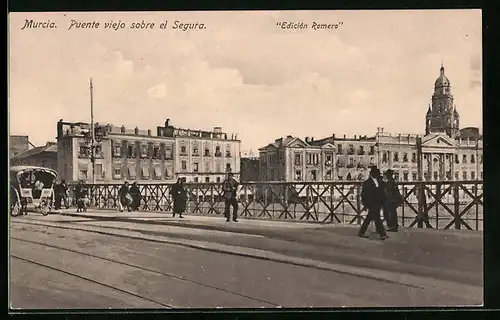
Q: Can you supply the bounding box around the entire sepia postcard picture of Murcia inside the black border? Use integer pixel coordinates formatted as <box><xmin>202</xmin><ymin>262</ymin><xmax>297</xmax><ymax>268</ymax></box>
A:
<box><xmin>7</xmin><ymin>9</ymin><xmax>484</xmax><ymax>312</ymax></box>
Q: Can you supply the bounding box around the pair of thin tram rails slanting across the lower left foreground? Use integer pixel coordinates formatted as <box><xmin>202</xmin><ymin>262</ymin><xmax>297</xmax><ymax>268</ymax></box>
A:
<box><xmin>10</xmin><ymin>228</ymin><xmax>281</xmax><ymax>308</ymax></box>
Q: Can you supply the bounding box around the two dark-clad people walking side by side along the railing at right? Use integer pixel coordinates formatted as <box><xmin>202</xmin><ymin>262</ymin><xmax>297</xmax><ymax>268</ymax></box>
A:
<box><xmin>358</xmin><ymin>167</ymin><xmax>403</xmax><ymax>240</ymax></box>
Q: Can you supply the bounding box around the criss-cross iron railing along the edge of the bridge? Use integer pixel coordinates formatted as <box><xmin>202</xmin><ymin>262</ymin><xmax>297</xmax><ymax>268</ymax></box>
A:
<box><xmin>70</xmin><ymin>180</ymin><xmax>484</xmax><ymax>230</ymax></box>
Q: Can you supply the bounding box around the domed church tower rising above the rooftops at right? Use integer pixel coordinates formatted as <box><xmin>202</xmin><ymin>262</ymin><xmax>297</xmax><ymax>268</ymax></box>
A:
<box><xmin>425</xmin><ymin>64</ymin><xmax>460</xmax><ymax>138</ymax></box>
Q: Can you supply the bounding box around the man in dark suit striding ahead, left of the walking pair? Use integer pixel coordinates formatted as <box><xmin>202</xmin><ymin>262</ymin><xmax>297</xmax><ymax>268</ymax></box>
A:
<box><xmin>358</xmin><ymin>167</ymin><xmax>388</xmax><ymax>240</ymax></box>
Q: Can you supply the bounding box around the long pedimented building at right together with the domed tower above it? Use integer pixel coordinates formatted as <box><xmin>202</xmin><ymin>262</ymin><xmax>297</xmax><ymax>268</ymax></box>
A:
<box><xmin>259</xmin><ymin>66</ymin><xmax>483</xmax><ymax>182</ymax></box>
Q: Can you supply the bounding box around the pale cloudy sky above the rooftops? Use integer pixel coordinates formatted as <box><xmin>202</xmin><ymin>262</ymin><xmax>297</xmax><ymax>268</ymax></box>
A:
<box><xmin>9</xmin><ymin>10</ymin><xmax>482</xmax><ymax>153</ymax></box>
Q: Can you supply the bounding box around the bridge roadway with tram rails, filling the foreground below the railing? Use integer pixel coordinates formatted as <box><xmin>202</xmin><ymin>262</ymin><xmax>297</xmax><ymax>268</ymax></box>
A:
<box><xmin>10</xmin><ymin>209</ymin><xmax>483</xmax><ymax>309</ymax></box>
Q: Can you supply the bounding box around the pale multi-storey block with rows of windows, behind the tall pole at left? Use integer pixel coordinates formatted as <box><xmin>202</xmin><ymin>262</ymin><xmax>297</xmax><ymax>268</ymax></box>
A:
<box><xmin>57</xmin><ymin>119</ymin><xmax>240</xmax><ymax>183</ymax></box>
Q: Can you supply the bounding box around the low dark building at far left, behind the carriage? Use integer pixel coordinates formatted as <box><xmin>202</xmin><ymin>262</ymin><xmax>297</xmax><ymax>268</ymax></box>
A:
<box><xmin>10</xmin><ymin>142</ymin><xmax>58</xmax><ymax>171</ymax></box>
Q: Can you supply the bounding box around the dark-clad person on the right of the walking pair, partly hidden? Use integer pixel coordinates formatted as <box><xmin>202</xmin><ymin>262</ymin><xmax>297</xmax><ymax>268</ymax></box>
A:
<box><xmin>383</xmin><ymin>169</ymin><xmax>403</xmax><ymax>232</ymax></box>
